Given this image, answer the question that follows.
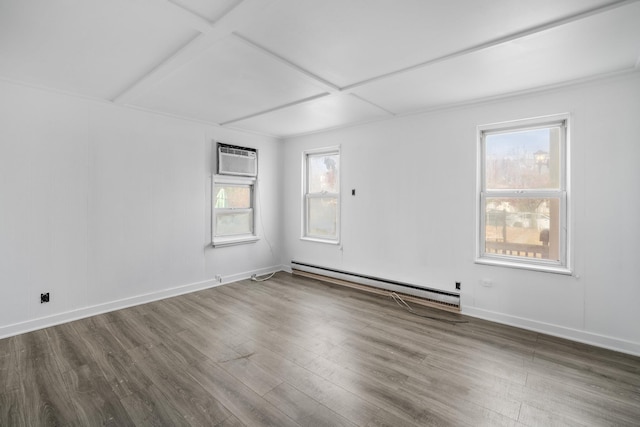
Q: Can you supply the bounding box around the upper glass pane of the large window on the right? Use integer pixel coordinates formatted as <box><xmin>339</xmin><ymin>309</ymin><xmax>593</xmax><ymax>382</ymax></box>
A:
<box><xmin>485</xmin><ymin>126</ymin><xmax>561</xmax><ymax>190</ymax></box>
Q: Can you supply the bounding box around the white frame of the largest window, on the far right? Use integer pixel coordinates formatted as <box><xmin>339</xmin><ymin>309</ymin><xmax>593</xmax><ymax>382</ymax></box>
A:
<box><xmin>475</xmin><ymin>114</ymin><xmax>572</xmax><ymax>274</ymax></box>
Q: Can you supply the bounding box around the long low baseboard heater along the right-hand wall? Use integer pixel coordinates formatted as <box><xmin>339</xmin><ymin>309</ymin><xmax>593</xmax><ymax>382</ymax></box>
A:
<box><xmin>291</xmin><ymin>261</ymin><xmax>460</xmax><ymax>312</ymax></box>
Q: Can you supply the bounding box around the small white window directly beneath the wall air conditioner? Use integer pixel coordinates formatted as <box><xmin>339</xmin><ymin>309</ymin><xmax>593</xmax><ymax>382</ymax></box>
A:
<box><xmin>211</xmin><ymin>175</ymin><xmax>258</xmax><ymax>246</ymax></box>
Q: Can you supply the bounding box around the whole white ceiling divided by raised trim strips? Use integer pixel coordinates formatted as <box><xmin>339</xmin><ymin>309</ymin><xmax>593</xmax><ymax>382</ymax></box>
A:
<box><xmin>0</xmin><ymin>0</ymin><xmax>640</xmax><ymax>137</ymax></box>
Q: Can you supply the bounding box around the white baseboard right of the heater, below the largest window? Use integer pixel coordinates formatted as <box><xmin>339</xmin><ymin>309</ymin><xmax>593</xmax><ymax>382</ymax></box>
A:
<box><xmin>462</xmin><ymin>305</ymin><xmax>640</xmax><ymax>356</ymax></box>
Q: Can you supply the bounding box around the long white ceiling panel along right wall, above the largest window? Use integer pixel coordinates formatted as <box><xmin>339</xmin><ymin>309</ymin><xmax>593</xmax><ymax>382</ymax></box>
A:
<box><xmin>353</xmin><ymin>3</ymin><xmax>640</xmax><ymax>114</ymax></box>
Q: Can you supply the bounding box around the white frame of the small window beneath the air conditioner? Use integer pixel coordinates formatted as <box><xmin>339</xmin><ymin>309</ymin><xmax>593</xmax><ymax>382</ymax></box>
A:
<box><xmin>211</xmin><ymin>175</ymin><xmax>260</xmax><ymax>247</ymax></box>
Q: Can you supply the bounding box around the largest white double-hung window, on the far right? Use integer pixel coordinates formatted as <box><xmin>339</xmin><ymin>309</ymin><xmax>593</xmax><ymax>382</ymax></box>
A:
<box><xmin>477</xmin><ymin>115</ymin><xmax>570</xmax><ymax>274</ymax></box>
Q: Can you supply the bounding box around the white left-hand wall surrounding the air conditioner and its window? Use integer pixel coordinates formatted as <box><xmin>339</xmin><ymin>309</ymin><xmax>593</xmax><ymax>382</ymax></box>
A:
<box><xmin>0</xmin><ymin>82</ymin><xmax>282</xmax><ymax>338</ymax></box>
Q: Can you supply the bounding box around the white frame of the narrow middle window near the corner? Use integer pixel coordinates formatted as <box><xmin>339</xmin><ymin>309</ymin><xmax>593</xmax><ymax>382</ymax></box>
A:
<box><xmin>300</xmin><ymin>146</ymin><xmax>342</xmax><ymax>245</ymax></box>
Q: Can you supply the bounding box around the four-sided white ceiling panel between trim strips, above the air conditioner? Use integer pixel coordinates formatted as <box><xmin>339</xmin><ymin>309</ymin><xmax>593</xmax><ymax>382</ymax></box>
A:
<box><xmin>133</xmin><ymin>36</ymin><xmax>330</xmax><ymax>123</ymax></box>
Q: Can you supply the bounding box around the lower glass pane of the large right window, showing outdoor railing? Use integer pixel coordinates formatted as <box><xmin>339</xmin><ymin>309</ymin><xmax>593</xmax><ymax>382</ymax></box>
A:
<box><xmin>485</xmin><ymin>197</ymin><xmax>560</xmax><ymax>261</ymax></box>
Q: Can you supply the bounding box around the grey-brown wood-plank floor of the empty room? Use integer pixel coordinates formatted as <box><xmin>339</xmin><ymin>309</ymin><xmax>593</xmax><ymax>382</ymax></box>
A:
<box><xmin>0</xmin><ymin>273</ymin><xmax>640</xmax><ymax>427</ymax></box>
